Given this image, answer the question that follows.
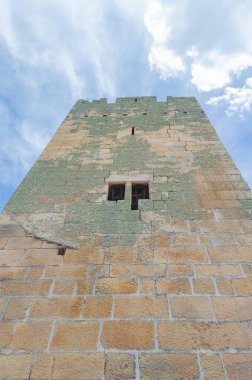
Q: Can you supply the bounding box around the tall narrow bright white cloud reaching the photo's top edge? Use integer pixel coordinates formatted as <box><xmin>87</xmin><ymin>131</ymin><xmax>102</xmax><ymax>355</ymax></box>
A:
<box><xmin>144</xmin><ymin>0</ymin><xmax>185</xmax><ymax>80</ymax></box>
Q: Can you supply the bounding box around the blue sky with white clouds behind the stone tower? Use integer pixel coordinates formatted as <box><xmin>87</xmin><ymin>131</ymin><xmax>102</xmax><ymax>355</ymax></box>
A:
<box><xmin>0</xmin><ymin>0</ymin><xmax>252</xmax><ymax>209</ymax></box>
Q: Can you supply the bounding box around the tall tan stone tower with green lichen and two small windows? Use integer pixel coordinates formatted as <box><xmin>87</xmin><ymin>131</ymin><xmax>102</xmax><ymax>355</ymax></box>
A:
<box><xmin>0</xmin><ymin>97</ymin><xmax>252</xmax><ymax>380</ymax></box>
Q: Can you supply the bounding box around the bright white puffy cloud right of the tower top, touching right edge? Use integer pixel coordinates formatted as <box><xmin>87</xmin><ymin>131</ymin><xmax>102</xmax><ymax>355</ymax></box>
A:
<box><xmin>189</xmin><ymin>48</ymin><xmax>252</xmax><ymax>91</ymax></box>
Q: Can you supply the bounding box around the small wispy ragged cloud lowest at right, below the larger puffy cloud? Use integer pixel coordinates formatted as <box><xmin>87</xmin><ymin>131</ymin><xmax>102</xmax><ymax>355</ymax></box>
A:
<box><xmin>207</xmin><ymin>77</ymin><xmax>252</xmax><ymax>117</ymax></box>
